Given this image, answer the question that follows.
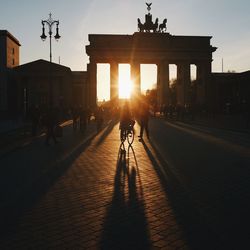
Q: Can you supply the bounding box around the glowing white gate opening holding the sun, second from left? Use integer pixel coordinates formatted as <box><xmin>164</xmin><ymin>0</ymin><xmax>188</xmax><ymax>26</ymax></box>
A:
<box><xmin>119</xmin><ymin>64</ymin><xmax>133</xmax><ymax>99</ymax></box>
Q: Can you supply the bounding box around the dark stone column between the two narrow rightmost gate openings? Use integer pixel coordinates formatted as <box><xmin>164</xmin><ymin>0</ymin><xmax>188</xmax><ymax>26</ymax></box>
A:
<box><xmin>177</xmin><ymin>62</ymin><xmax>191</xmax><ymax>107</ymax></box>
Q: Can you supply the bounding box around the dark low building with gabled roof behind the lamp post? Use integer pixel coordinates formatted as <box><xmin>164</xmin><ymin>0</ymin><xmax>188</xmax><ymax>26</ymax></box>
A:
<box><xmin>9</xmin><ymin>59</ymin><xmax>72</xmax><ymax>116</ymax></box>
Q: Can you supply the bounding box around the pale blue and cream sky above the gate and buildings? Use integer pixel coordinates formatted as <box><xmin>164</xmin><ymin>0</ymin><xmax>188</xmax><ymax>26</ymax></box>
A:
<box><xmin>0</xmin><ymin>0</ymin><xmax>250</xmax><ymax>98</ymax></box>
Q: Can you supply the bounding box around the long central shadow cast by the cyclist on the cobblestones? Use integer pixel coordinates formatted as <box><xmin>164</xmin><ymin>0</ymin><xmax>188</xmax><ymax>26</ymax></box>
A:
<box><xmin>100</xmin><ymin>143</ymin><xmax>151</xmax><ymax>250</ymax></box>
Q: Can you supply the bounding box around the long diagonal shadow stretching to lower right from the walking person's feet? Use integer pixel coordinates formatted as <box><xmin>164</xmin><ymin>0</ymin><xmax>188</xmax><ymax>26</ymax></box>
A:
<box><xmin>142</xmin><ymin>141</ymin><xmax>224</xmax><ymax>250</ymax></box>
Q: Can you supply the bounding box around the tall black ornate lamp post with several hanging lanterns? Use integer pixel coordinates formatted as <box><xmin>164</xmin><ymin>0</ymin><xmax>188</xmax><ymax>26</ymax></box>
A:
<box><xmin>40</xmin><ymin>13</ymin><xmax>61</xmax><ymax>107</ymax></box>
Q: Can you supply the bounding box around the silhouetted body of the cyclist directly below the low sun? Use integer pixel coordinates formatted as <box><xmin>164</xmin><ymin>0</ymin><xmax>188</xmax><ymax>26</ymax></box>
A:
<box><xmin>119</xmin><ymin>102</ymin><xmax>135</xmax><ymax>141</ymax></box>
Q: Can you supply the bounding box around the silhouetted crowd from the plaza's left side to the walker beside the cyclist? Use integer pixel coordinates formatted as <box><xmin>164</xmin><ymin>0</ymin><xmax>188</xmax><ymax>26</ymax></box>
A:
<box><xmin>29</xmin><ymin>97</ymin><xmax>152</xmax><ymax>145</ymax></box>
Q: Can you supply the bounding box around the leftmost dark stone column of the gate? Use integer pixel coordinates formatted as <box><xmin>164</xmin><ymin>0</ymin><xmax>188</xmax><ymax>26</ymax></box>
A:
<box><xmin>88</xmin><ymin>62</ymin><xmax>97</xmax><ymax>109</ymax></box>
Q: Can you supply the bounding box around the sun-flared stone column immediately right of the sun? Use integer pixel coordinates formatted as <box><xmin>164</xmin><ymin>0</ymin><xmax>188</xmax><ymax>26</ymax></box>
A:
<box><xmin>130</xmin><ymin>61</ymin><xmax>141</xmax><ymax>97</ymax></box>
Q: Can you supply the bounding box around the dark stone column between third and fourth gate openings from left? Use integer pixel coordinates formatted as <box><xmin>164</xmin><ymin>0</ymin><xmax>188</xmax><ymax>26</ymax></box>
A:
<box><xmin>157</xmin><ymin>61</ymin><xmax>170</xmax><ymax>106</ymax></box>
